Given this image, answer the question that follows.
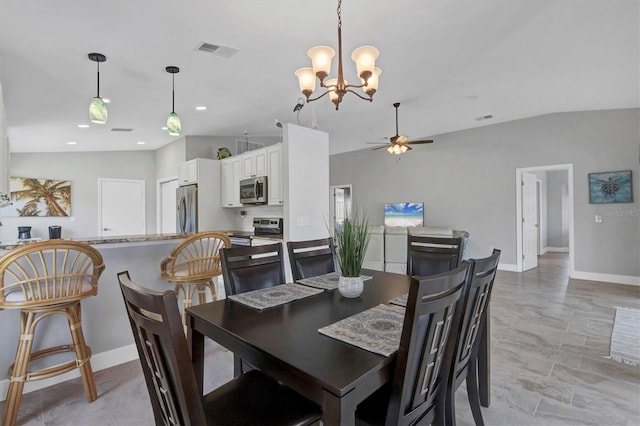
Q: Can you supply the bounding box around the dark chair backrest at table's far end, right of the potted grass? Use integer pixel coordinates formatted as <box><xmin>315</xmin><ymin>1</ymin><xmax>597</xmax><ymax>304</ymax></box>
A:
<box><xmin>407</xmin><ymin>235</ymin><xmax>463</xmax><ymax>276</ymax></box>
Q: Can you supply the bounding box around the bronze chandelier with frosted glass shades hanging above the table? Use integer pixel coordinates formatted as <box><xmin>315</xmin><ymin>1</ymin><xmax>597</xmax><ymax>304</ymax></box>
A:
<box><xmin>295</xmin><ymin>0</ymin><xmax>382</xmax><ymax>110</ymax></box>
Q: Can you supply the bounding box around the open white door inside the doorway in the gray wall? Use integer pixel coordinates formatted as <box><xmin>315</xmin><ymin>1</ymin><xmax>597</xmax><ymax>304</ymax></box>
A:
<box><xmin>522</xmin><ymin>173</ymin><xmax>538</xmax><ymax>271</ymax></box>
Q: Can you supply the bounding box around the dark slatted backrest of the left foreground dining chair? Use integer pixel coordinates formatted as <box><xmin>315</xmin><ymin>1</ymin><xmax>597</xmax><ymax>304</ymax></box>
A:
<box><xmin>118</xmin><ymin>272</ymin><xmax>206</xmax><ymax>425</ymax></box>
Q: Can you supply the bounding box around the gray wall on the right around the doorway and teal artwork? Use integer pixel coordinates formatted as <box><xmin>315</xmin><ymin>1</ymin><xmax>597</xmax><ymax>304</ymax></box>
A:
<box><xmin>330</xmin><ymin>108</ymin><xmax>640</xmax><ymax>280</ymax></box>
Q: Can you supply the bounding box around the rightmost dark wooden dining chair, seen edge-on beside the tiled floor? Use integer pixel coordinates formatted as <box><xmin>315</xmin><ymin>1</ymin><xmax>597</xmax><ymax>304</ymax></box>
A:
<box><xmin>445</xmin><ymin>249</ymin><xmax>500</xmax><ymax>426</ymax></box>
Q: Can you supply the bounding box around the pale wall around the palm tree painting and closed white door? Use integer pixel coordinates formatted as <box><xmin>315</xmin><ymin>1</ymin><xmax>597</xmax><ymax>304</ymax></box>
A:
<box><xmin>0</xmin><ymin>151</ymin><xmax>156</xmax><ymax>241</ymax></box>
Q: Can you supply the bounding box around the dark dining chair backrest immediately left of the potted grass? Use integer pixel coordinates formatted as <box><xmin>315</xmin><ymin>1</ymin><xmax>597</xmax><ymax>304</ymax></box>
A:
<box><xmin>287</xmin><ymin>238</ymin><xmax>337</xmax><ymax>281</ymax></box>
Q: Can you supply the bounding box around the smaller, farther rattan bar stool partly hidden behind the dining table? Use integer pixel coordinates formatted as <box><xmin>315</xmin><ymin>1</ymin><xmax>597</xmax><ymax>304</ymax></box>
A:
<box><xmin>160</xmin><ymin>231</ymin><xmax>231</xmax><ymax>332</ymax></box>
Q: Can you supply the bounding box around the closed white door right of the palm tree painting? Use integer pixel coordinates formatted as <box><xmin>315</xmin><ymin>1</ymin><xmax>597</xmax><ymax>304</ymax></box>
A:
<box><xmin>98</xmin><ymin>179</ymin><xmax>146</xmax><ymax>237</ymax></box>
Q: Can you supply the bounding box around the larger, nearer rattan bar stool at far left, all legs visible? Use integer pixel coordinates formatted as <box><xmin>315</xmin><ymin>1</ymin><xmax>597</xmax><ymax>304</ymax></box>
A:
<box><xmin>0</xmin><ymin>240</ymin><xmax>104</xmax><ymax>426</ymax></box>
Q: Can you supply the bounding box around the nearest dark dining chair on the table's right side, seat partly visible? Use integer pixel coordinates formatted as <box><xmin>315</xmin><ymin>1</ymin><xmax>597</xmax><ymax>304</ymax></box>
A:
<box><xmin>356</xmin><ymin>262</ymin><xmax>468</xmax><ymax>425</ymax></box>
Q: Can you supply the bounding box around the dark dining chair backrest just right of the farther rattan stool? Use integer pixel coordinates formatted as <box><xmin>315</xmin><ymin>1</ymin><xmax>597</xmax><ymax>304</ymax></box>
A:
<box><xmin>220</xmin><ymin>243</ymin><xmax>286</xmax><ymax>296</ymax></box>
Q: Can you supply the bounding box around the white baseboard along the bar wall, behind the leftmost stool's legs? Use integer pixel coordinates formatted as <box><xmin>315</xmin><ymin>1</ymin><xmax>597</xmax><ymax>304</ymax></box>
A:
<box><xmin>0</xmin><ymin>344</ymin><xmax>138</xmax><ymax>401</ymax></box>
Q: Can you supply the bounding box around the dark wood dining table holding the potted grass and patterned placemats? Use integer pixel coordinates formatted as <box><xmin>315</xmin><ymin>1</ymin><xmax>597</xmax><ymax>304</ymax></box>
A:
<box><xmin>186</xmin><ymin>269</ymin><xmax>489</xmax><ymax>425</ymax></box>
